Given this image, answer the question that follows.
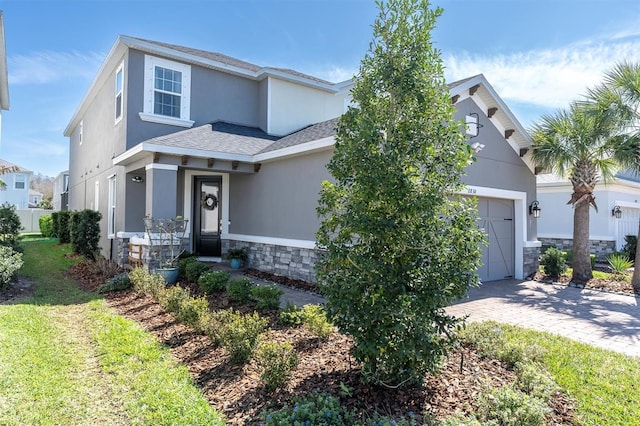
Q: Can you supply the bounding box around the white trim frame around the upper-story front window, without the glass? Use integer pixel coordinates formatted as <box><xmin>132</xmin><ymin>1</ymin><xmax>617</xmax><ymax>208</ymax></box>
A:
<box><xmin>139</xmin><ymin>55</ymin><xmax>194</xmax><ymax>127</ymax></box>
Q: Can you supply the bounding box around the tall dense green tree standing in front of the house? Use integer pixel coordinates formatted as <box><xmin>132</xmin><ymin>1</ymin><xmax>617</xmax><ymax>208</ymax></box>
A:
<box><xmin>317</xmin><ymin>0</ymin><xmax>483</xmax><ymax>386</ymax></box>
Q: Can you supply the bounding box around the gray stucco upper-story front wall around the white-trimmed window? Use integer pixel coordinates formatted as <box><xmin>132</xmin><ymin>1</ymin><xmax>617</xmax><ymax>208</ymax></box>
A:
<box><xmin>127</xmin><ymin>50</ymin><xmax>260</xmax><ymax>149</ymax></box>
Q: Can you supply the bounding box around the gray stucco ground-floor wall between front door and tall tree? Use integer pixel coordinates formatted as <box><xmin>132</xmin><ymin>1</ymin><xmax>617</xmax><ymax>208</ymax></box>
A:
<box><xmin>229</xmin><ymin>150</ymin><xmax>333</xmax><ymax>241</ymax></box>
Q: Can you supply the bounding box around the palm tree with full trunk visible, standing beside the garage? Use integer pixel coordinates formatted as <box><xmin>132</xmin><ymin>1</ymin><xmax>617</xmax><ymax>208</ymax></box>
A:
<box><xmin>532</xmin><ymin>103</ymin><xmax>616</xmax><ymax>283</ymax></box>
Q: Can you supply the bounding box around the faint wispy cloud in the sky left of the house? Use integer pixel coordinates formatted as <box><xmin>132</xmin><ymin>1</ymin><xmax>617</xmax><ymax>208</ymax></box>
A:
<box><xmin>7</xmin><ymin>51</ymin><xmax>105</xmax><ymax>84</ymax></box>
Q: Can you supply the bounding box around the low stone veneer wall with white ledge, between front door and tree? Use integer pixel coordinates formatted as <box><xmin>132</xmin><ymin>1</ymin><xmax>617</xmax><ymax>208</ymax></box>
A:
<box><xmin>222</xmin><ymin>240</ymin><xmax>319</xmax><ymax>283</ymax></box>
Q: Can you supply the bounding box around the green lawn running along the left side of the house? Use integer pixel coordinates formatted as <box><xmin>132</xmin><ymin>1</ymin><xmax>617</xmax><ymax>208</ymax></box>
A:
<box><xmin>0</xmin><ymin>240</ymin><xmax>224</xmax><ymax>425</ymax></box>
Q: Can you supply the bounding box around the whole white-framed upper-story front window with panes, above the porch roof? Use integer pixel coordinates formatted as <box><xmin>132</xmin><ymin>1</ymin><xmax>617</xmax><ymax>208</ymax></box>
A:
<box><xmin>140</xmin><ymin>55</ymin><xmax>193</xmax><ymax>127</ymax></box>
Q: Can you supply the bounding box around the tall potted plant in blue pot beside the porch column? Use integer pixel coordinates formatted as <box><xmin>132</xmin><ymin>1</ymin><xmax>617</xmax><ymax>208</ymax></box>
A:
<box><xmin>144</xmin><ymin>216</ymin><xmax>188</xmax><ymax>284</ymax></box>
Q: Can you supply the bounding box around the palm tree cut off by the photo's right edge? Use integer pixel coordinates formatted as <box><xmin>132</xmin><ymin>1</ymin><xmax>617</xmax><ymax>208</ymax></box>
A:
<box><xmin>588</xmin><ymin>62</ymin><xmax>640</xmax><ymax>293</ymax></box>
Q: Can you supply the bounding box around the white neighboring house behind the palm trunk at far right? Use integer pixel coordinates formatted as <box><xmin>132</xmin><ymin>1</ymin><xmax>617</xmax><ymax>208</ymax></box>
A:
<box><xmin>537</xmin><ymin>172</ymin><xmax>640</xmax><ymax>261</ymax></box>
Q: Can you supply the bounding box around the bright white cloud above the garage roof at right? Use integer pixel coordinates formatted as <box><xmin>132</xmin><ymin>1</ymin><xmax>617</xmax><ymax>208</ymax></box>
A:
<box><xmin>443</xmin><ymin>32</ymin><xmax>640</xmax><ymax>108</ymax></box>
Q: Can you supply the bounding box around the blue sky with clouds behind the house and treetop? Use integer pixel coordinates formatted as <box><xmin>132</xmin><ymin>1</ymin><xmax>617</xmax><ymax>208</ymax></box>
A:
<box><xmin>0</xmin><ymin>0</ymin><xmax>640</xmax><ymax>176</ymax></box>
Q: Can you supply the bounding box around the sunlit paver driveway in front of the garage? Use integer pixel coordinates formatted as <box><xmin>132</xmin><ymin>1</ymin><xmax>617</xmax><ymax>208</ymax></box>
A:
<box><xmin>447</xmin><ymin>280</ymin><xmax>640</xmax><ymax>356</ymax></box>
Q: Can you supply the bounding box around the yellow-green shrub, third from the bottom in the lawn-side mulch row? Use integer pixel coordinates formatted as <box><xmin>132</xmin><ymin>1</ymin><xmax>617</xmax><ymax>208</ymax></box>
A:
<box><xmin>220</xmin><ymin>312</ymin><xmax>267</xmax><ymax>363</ymax></box>
